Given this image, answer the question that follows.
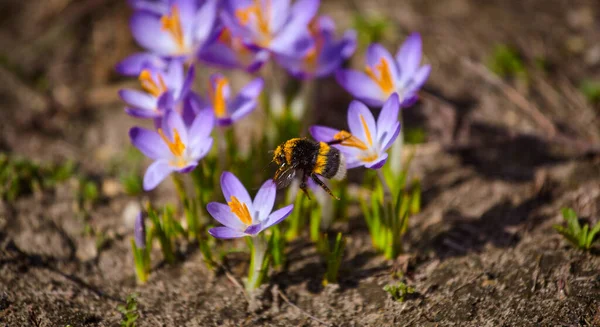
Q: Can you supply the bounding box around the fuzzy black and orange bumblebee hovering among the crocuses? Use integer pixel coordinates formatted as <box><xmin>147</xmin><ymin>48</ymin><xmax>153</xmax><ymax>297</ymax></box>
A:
<box><xmin>273</xmin><ymin>138</ymin><xmax>346</xmax><ymax>200</ymax></box>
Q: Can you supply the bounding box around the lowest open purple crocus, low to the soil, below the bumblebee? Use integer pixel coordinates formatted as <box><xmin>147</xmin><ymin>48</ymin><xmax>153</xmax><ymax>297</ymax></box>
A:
<box><xmin>206</xmin><ymin>172</ymin><xmax>294</xmax><ymax>239</ymax></box>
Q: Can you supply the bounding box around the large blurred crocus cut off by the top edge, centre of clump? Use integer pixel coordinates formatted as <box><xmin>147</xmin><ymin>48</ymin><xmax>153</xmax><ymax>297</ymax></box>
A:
<box><xmin>221</xmin><ymin>0</ymin><xmax>319</xmax><ymax>56</ymax></box>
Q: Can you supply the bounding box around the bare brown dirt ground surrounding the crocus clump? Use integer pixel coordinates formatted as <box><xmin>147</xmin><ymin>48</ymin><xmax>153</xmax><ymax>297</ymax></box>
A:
<box><xmin>0</xmin><ymin>0</ymin><xmax>600</xmax><ymax>327</ymax></box>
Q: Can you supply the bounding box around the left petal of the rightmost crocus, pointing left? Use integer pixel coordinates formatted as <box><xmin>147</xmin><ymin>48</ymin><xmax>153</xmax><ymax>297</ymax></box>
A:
<box><xmin>335</xmin><ymin>70</ymin><xmax>387</xmax><ymax>107</ymax></box>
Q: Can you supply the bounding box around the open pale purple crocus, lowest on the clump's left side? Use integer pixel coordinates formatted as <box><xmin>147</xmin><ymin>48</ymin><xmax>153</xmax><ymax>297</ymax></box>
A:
<box><xmin>129</xmin><ymin>110</ymin><xmax>214</xmax><ymax>191</ymax></box>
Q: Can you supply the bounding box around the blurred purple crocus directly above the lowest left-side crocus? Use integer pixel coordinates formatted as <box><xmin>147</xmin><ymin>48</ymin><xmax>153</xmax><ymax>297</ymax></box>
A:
<box><xmin>119</xmin><ymin>60</ymin><xmax>195</xmax><ymax>124</ymax></box>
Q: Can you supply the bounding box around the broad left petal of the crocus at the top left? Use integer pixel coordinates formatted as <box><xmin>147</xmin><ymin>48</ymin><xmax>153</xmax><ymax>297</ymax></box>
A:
<box><xmin>130</xmin><ymin>11</ymin><xmax>178</xmax><ymax>56</ymax></box>
